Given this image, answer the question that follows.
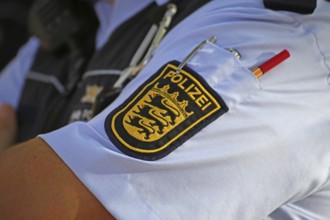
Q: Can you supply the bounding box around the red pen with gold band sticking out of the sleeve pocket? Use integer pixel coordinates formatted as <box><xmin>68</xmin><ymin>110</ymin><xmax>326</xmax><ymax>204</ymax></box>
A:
<box><xmin>252</xmin><ymin>50</ymin><xmax>290</xmax><ymax>78</ymax></box>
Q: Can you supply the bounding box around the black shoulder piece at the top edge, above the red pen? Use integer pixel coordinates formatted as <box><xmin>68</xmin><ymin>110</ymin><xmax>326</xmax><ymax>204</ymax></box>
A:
<box><xmin>264</xmin><ymin>0</ymin><xmax>316</xmax><ymax>14</ymax></box>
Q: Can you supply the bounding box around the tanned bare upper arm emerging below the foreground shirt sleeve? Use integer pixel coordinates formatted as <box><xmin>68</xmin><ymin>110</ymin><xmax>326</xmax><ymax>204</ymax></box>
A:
<box><xmin>0</xmin><ymin>138</ymin><xmax>113</xmax><ymax>220</ymax></box>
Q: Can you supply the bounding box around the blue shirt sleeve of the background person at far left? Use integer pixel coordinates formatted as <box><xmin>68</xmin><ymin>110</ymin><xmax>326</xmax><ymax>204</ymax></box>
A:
<box><xmin>0</xmin><ymin>37</ymin><xmax>39</xmax><ymax>108</ymax></box>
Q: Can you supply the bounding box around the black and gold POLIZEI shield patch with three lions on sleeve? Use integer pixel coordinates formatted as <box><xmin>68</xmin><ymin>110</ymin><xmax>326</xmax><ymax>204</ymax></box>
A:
<box><xmin>105</xmin><ymin>61</ymin><xmax>228</xmax><ymax>160</ymax></box>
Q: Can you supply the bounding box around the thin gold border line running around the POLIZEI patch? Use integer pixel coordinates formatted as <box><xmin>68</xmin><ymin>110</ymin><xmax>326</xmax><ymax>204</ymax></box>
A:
<box><xmin>111</xmin><ymin>64</ymin><xmax>222</xmax><ymax>154</ymax></box>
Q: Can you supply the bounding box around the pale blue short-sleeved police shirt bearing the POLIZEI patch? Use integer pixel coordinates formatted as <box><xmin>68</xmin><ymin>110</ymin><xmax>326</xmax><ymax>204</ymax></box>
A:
<box><xmin>0</xmin><ymin>0</ymin><xmax>330</xmax><ymax>219</ymax></box>
